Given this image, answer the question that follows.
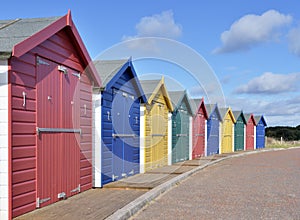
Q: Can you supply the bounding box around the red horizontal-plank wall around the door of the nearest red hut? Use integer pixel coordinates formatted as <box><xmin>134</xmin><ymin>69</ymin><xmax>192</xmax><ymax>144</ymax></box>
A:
<box><xmin>9</xmin><ymin>29</ymin><xmax>92</xmax><ymax>217</ymax></box>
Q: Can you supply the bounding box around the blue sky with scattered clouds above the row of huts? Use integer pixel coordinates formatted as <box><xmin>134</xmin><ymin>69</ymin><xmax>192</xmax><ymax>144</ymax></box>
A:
<box><xmin>0</xmin><ymin>0</ymin><xmax>300</xmax><ymax>126</ymax></box>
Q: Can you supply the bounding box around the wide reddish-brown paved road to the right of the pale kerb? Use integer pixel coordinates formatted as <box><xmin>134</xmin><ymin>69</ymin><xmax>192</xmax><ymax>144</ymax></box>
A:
<box><xmin>132</xmin><ymin>148</ymin><xmax>300</xmax><ymax>220</ymax></box>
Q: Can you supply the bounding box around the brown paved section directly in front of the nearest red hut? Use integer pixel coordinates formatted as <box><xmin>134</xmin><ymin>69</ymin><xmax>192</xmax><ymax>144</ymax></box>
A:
<box><xmin>15</xmin><ymin>189</ymin><xmax>147</xmax><ymax>220</ymax></box>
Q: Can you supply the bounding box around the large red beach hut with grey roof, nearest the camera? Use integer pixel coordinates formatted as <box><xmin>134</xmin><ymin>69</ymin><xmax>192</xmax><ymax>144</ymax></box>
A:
<box><xmin>0</xmin><ymin>12</ymin><xmax>100</xmax><ymax>219</ymax></box>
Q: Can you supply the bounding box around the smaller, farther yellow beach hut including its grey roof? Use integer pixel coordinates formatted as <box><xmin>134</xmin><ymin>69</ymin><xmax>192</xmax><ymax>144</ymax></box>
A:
<box><xmin>219</xmin><ymin>108</ymin><xmax>236</xmax><ymax>154</ymax></box>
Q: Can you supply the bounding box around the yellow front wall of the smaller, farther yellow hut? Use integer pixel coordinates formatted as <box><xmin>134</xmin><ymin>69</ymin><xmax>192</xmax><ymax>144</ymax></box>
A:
<box><xmin>220</xmin><ymin>111</ymin><xmax>234</xmax><ymax>154</ymax></box>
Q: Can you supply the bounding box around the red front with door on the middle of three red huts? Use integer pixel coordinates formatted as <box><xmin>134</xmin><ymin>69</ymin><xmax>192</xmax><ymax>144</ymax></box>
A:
<box><xmin>192</xmin><ymin>112</ymin><xmax>205</xmax><ymax>159</ymax></box>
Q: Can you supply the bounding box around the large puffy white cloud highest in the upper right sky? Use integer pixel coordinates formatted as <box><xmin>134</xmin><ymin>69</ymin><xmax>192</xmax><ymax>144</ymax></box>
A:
<box><xmin>213</xmin><ymin>10</ymin><xmax>292</xmax><ymax>53</ymax></box>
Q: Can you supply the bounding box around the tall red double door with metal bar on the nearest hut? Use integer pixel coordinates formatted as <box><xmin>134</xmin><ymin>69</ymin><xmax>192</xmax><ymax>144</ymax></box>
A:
<box><xmin>37</xmin><ymin>57</ymin><xmax>80</xmax><ymax>207</ymax></box>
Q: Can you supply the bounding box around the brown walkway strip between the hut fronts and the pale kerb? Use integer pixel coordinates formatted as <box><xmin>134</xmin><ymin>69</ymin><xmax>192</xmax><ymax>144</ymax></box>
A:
<box><xmin>15</xmin><ymin>152</ymin><xmax>233</xmax><ymax>220</ymax></box>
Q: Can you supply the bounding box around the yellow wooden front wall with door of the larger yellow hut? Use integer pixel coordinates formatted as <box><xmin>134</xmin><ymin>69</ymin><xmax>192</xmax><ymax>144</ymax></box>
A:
<box><xmin>144</xmin><ymin>92</ymin><xmax>169</xmax><ymax>171</ymax></box>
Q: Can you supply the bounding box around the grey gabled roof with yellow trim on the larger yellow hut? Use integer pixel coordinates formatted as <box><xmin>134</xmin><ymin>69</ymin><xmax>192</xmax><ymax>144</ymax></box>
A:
<box><xmin>140</xmin><ymin>77</ymin><xmax>174</xmax><ymax>112</ymax></box>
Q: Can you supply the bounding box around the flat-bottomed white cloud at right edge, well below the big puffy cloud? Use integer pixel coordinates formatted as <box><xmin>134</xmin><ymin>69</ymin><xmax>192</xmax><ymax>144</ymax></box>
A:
<box><xmin>235</xmin><ymin>72</ymin><xmax>300</xmax><ymax>94</ymax></box>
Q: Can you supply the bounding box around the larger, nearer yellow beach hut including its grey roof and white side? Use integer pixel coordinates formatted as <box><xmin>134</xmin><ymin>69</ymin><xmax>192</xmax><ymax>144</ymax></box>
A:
<box><xmin>140</xmin><ymin>77</ymin><xmax>173</xmax><ymax>173</ymax></box>
